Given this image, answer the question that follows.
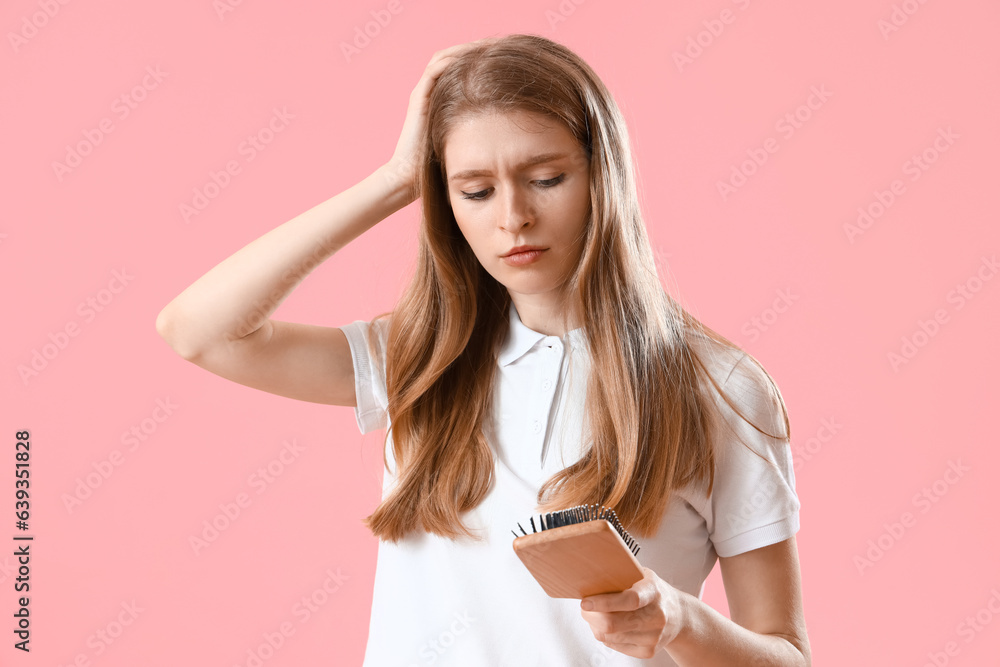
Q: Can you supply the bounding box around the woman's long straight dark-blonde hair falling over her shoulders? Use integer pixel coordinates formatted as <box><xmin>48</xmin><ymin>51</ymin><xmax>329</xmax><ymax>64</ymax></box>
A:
<box><xmin>365</xmin><ymin>34</ymin><xmax>790</xmax><ymax>541</ymax></box>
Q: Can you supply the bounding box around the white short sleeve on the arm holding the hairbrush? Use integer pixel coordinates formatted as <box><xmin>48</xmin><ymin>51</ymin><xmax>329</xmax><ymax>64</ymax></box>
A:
<box><xmin>706</xmin><ymin>354</ymin><xmax>800</xmax><ymax>557</ymax></box>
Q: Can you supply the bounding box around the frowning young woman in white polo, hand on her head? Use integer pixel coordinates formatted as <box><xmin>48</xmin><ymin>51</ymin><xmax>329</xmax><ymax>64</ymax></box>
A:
<box><xmin>156</xmin><ymin>35</ymin><xmax>810</xmax><ymax>667</ymax></box>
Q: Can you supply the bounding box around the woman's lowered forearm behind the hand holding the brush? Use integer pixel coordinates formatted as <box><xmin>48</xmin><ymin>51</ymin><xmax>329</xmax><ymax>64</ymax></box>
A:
<box><xmin>666</xmin><ymin>592</ymin><xmax>811</xmax><ymax>667</ymax></box>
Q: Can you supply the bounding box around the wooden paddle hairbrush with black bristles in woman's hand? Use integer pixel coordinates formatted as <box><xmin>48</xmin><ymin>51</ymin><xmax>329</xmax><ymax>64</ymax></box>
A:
<box><xmin>512</xmin><ymin>505</ymin><xmax>644</xmax><ymax>599</ymax></box>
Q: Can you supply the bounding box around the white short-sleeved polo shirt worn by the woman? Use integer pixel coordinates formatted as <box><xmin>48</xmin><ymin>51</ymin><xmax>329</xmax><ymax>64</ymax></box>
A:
<box><xmin>341</xmin><ymin>304</ymin><xmax>800</xmax><ymax>667</ymax></box>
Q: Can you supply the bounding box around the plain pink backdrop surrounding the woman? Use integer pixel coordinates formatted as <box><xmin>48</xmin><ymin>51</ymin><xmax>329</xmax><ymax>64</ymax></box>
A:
<box><xmin>0</xmin><ymin>0</ymin><xmax>1000</xmax><ymax>667</ymax></box>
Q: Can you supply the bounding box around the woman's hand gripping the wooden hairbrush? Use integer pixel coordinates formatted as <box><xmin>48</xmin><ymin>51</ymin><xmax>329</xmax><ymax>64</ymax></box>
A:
<box><xmin>580</xmin><ymin>567</ymin><xmax>684</xmax><ymax>658</ymax></box>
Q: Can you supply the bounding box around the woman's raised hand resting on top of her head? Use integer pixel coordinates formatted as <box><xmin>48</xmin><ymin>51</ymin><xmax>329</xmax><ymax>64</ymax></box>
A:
<box><xmin>384</xmin><ymin>37</ymin><xmax>498</xmax><ymax>202</ymax></box>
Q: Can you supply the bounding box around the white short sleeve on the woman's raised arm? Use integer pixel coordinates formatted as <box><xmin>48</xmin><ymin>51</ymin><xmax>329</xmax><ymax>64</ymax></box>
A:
<box><xmin>340</xmin><ymin>320</ymin><xmax>389</xmax><ymax>434</ymax></box>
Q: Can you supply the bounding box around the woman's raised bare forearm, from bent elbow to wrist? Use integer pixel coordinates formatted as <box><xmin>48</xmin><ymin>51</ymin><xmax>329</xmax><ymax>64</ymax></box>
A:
<box><xmin>156</xmin><ymin>164</ymin><xmax>413</xmax><ymax>359</ymax></box>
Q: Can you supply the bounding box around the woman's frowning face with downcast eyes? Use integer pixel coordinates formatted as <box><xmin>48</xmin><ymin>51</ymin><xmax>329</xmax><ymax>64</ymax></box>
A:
<box><xmin>443</xmin><ymin>112</ymin><xmax>590</xmax><ymax>311</ymax></box>
